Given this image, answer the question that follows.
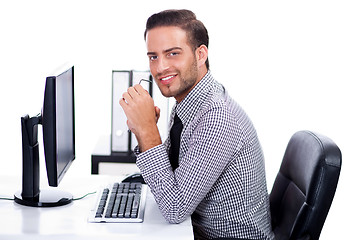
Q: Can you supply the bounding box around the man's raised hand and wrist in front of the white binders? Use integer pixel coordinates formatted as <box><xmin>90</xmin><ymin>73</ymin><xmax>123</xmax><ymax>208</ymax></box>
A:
<box><xmin>119</xmin><ymin>84</ymin><xmax>161</xmax><ymax>152</ymax></box>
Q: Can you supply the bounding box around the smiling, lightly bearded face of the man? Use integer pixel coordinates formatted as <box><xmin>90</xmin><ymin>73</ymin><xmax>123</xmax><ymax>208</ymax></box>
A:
<box><xmin>146</xmin><ymin>26</ymin><xmax>201</xmax><ymax>102</ymax></box>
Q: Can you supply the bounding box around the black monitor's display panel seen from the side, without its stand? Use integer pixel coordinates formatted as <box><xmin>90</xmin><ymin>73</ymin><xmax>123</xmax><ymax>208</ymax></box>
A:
<box><xmin>42</xmin><ymin>67</ymin><xmax>75</xmax><ymax>187</ymax></box>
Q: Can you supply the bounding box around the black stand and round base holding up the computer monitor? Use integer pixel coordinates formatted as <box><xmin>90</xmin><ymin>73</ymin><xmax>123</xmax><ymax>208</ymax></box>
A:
<box><xmin>14</xmin><ymin>114</ymin><xmax>73</xmax><ymax>207</ymax></box>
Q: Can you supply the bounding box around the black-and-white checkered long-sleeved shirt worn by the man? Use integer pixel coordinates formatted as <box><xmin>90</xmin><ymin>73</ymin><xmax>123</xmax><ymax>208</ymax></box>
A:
<box><xmin>135</xmin><ymin>72</ymin><xmax>273</xmax><ymax>239</ymax></box>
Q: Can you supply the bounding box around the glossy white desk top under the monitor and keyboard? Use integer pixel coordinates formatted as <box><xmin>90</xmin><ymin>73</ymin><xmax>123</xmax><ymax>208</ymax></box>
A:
<box><xmin>0</xmin><ymin>175</ymin><xmax>193</xmax><ymax>240</ymax></box>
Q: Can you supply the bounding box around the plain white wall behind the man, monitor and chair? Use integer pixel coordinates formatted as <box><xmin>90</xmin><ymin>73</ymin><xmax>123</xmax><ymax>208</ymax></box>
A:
<box><xmin>0</xmin><ymin>0</ymin><xmax>360</xmax><ymax>239</ymax></box>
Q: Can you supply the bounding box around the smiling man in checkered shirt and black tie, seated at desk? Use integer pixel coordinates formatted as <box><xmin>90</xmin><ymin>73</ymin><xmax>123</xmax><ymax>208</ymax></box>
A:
<box><xmin>120</xmin><ymin>10</ymin><xmax>273</xmax><ymax>239</ymax></box>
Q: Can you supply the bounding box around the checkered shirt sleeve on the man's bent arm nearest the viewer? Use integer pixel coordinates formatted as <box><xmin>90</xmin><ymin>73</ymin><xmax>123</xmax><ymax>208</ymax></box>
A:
<box><xmin>137</xmin><ymin>107</ymin><xmax>238</xmax><ymax>223</ymax></box>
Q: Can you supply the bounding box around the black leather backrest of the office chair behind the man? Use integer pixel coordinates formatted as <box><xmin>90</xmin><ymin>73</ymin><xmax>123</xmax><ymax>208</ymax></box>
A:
<box><xmin>270</xmin><ymin>131</ymin><xmax>342</xmax><ymax>240</ymax></box>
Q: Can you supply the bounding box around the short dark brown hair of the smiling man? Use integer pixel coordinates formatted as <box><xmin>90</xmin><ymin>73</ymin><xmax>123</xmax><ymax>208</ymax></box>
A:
<box><xmin>144</xmin><ymin>9</ymin><xmax>209</xmax><ymax>69</ymax></box>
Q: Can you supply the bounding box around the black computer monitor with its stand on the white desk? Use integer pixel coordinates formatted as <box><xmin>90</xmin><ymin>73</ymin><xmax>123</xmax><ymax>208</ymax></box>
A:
<box><xmin>15</xmin><ymin>66</ymin><xmax>75</xmax><ymax>207</ymax></box>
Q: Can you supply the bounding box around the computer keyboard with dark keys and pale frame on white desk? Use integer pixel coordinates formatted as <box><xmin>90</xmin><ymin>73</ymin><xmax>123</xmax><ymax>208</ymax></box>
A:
<box><xmin>88</xmin><ymin>182</ymin><xmax>147</xmax><ymax>222</ymax></box>
